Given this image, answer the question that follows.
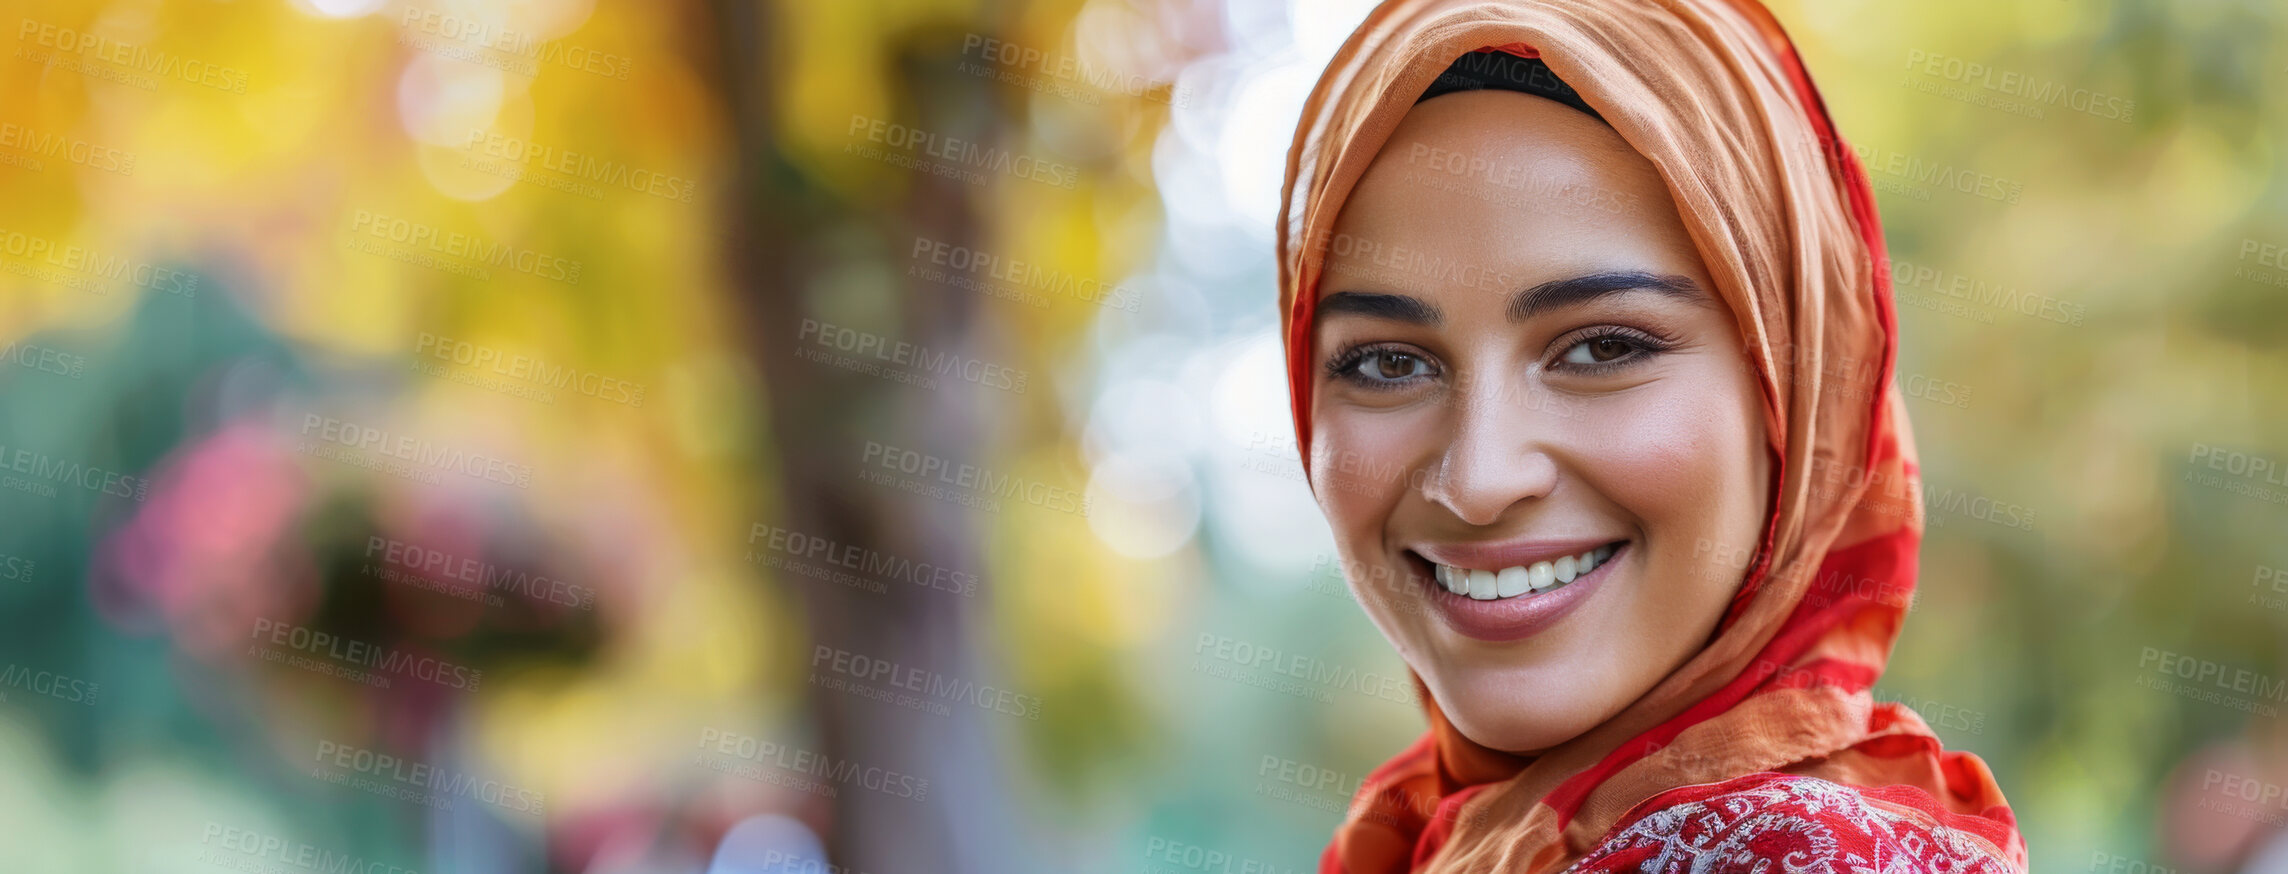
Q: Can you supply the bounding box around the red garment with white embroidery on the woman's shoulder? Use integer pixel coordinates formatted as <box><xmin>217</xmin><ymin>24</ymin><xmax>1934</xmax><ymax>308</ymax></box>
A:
<box><xmin>1570</xmin><ymin>771</ymin><xmax>2023</xmax><ymax>874</ymax></box>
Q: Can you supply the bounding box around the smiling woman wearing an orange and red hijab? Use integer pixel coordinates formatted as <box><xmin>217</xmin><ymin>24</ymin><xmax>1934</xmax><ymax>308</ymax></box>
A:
<box><xmin>1279</xmin><ymin>0</ymin><xmax>2025</xmax><ymax>874</ymax></box>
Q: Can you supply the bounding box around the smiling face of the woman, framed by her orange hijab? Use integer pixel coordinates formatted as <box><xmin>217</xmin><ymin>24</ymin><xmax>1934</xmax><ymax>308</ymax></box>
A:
<box><xmin>1311</xmin><ymin>92</ymin><xmax>1771</xmax><ymax>753</ymax></box>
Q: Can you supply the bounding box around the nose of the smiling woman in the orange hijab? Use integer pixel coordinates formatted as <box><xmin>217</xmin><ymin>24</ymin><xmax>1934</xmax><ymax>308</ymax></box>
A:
<box><xmin>1423</xmin><ymin>382</ymin><xmax>1558</xmax><ymax>526</ymax></box>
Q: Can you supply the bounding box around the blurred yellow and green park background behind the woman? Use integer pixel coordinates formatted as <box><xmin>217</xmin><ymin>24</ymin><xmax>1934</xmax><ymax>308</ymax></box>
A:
<box><xmin>0</xmin><ymin>0</ymin><xmax>2288</xmax><ymax>874</ymax></box>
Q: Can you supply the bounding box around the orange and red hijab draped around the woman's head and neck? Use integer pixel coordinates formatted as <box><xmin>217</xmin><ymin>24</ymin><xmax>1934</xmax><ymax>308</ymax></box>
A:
<box><xmin>1279</xmin><ymin>0</ymin><xmax>2025</xmax><ymax>874</ymax></box>
